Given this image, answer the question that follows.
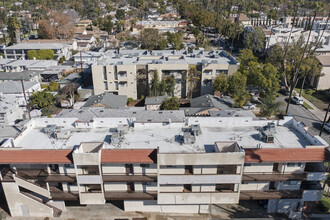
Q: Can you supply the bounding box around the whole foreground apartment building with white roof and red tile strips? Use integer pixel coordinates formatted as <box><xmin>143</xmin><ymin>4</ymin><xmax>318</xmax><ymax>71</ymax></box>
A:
<box><xmin>0</xmin><ymin>108</ymin><xmax>330</xmax><ymax>217</ymax></box>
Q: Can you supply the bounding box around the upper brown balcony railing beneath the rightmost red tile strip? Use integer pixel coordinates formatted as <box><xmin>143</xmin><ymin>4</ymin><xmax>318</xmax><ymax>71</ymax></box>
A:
<box><xmin>242</xmin><ymin>172</ymin><xmax>306</xmax><ymax>181</ymax></box>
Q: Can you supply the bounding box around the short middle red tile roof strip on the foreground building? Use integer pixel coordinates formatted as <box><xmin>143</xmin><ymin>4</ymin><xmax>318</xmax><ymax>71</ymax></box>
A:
<box><xmin>101</xmin><ymin>149</ymin><xmax>157</xmax><ymax>164</ymax></box>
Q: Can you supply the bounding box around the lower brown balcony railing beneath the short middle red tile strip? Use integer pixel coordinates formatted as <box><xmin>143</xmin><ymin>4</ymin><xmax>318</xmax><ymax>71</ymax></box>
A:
<box><xmin>104</xmin><ymin>191</ymin><xmax>157</xmax><ymax>200</ymax></box>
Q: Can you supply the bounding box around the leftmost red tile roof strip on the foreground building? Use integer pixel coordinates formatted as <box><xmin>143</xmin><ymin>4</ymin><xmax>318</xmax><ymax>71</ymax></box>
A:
<box><xmin>0</xmin><ymin>150</ymin><xmax>72</xmax><ymax>164</ymax></box>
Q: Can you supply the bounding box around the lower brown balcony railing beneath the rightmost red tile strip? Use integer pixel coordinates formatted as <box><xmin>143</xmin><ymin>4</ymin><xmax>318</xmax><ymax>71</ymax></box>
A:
<box><xmin>239</xmin><ymin>190</ymin><xmax>302</xmax><ymax>200</ymax></box>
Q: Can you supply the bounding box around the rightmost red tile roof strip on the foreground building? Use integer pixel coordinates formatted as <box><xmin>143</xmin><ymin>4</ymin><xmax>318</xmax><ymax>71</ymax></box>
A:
<box><xmin>244</xmin><ymin>148</ymin><xmax>330</xmax><ymax>163</ymax></box>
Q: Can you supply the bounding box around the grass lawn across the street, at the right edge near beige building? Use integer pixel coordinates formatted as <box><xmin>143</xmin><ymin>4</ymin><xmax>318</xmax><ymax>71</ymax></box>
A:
<box><xmin>295</xmin><ymin>88</ymin><xmax>330</xmax><ymax>110</ymax></box>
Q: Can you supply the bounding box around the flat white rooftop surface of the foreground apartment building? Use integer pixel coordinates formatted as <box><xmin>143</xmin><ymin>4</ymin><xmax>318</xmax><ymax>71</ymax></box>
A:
<box><xmin>16</xmin><ymin>123</ymin><xmax>311</xmax><ymax>152</ymax></box>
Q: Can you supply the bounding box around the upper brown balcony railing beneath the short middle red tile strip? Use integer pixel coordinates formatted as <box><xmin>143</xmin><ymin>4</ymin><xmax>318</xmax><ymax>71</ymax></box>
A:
<box><xmin>102</xmin><ymin>175</ymin><xmax>157</xmax><ymax>182</ymax></box>
